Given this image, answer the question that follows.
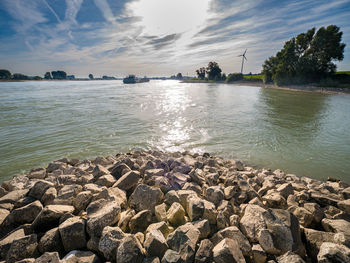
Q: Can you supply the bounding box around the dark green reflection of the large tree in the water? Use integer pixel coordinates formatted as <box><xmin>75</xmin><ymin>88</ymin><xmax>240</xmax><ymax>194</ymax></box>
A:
<box><xmin>259</xmin><ymin>88</ymin><xmax>328</xmax><ymax>136</ymax></box>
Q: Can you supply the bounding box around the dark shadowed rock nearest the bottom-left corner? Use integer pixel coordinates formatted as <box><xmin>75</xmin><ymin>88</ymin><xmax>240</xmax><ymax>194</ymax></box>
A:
<box><xmin>6</xmin><ymin>234</ymin><xmax>38</xmax><ymax>263</ymax></box>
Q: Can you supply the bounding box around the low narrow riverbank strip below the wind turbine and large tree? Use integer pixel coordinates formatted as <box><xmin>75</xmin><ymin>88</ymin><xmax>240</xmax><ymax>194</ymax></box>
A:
<box><xmin>182</xmin><ymin>80</ymin><xmax>350</xmax><ymax>94</ymax></box>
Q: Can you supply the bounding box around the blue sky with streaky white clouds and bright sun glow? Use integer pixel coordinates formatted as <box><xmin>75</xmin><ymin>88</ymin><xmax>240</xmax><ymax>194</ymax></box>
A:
<box><xmin>0</xmin><ymin>0</ymin><xmax>350</xmax><ymax>77</ymax></box>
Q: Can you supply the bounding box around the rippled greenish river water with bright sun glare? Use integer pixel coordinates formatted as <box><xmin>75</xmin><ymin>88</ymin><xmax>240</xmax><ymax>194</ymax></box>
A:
<box><xmin>0</xmin><ymin>80</ymin><xmax>350</xmax><ymax>181</ymax></box>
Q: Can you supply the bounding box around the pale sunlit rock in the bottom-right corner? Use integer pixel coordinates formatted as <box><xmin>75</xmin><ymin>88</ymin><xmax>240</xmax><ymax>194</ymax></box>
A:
<box><xmin>317</xmin><ymin>242</ymin><xmax>350</xmax><ymax>263</ymax></box>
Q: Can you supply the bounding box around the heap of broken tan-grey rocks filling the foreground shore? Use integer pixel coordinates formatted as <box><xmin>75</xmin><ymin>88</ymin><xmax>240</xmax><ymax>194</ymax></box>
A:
<box><xmin>0</xmin><ymin>151</ymin><xmax>350</xmax><ymax>263</ymax></box>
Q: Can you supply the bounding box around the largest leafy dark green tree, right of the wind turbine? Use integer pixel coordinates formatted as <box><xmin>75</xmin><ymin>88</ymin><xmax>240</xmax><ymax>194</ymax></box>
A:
<box><xmin>263</xmin><ymin>25</ymin><xmax>345</xmax><ymax>85</ymax></box>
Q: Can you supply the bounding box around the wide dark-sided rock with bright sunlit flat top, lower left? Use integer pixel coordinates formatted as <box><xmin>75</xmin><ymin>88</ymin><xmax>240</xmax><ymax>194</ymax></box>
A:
<box><xmin>32</xmin><ymin>205</ymin><xmax>74</xmax><ymax>232</ymax></box>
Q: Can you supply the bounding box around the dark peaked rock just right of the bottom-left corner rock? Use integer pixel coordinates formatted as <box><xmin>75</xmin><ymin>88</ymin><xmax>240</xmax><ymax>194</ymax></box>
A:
<box><xmin>38</xmin><ymin>227</ymin><xmax>64</xmax><ymax>253</ymax></box>
